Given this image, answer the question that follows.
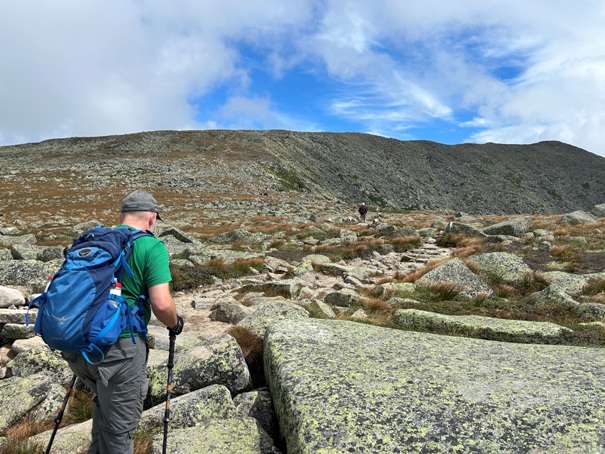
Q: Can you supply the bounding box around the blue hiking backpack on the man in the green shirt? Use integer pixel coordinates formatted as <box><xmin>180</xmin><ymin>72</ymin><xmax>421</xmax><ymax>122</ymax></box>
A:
<box><xmin>27</xmin><ymin>226</ymin><xmax>149</xmax><ymax>364</ymax></box>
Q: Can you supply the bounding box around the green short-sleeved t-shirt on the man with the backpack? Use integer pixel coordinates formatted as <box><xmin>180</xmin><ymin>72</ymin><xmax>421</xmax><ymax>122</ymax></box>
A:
<box><xmin>117</xmin><ymin>224</ymin><xmax>172</xmax><ymax>324</ymax></box>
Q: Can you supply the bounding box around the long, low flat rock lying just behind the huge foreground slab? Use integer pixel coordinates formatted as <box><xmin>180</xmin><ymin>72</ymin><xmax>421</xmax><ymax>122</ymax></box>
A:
<box><xmin>393</xmin><ymin>309</ymin><xmax>571</xmax><ymax>342</ymax></box>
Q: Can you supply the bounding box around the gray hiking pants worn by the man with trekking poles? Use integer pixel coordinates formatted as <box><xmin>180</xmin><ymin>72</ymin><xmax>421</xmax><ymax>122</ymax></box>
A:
<box><xmin>63</xmin><ymin>337</ymin><xmax>147</xmax><ymax>454</ymax></box>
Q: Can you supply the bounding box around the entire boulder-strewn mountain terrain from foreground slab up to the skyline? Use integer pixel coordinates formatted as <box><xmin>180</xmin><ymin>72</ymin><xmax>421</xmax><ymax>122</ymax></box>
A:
<box><xmin>0</xmin><ymin>131</ymin><xmax>605</xmax><ymax>454</ymax></box>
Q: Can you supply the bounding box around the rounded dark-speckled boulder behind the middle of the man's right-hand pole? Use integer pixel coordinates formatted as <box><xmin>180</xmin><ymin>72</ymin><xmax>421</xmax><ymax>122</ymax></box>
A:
<box><xmin>148</xmin><ymin>334</ymin><xmax>251</xmax><ymax>404</ymax></box>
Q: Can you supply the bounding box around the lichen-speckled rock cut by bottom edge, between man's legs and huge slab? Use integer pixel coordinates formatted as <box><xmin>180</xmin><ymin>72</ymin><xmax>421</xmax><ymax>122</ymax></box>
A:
<box><xmin>151</xmin><ymin>418</ymin><xmax>279</xmax><ymax>454</ymax></box>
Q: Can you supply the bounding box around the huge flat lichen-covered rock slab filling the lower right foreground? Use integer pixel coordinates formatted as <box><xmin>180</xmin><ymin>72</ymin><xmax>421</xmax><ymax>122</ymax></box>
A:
<box><xmin>265</xmin><ymin>319</ymin><xmax>605</xmax><ymax>454</ymax></box>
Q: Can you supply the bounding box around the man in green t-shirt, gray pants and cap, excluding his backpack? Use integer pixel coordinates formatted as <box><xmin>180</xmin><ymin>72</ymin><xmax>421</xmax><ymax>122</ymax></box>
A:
<box><xmin>63</xmin><ymin>190</ymin><xmax>183</xmax><ymax>454</ymax></box>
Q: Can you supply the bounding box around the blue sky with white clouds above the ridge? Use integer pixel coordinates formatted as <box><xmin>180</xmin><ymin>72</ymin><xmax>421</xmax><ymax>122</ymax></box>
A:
<box><xmin>0</xmin><ymin>0</ymin><xmax>605</xmax><ymax>156</ymax></box>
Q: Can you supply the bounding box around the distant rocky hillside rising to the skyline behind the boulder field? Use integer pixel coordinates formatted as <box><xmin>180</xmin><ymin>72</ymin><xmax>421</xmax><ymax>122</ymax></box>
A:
<box><xmin>0</xmin><ymin>130</ymin><xmax>605</xmax><ymax>223</ymax></box>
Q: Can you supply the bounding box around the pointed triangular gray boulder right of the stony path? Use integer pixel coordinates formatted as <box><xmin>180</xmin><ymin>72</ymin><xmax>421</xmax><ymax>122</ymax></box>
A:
<box><xmin>416</xmin><ymin>258</ymin><xmax>493</xmax><ymax>297</ymax></box>
